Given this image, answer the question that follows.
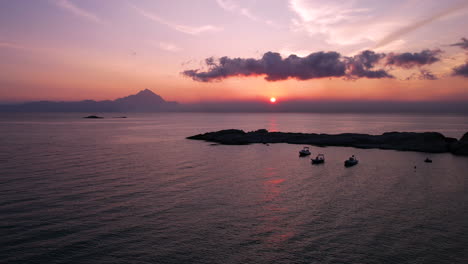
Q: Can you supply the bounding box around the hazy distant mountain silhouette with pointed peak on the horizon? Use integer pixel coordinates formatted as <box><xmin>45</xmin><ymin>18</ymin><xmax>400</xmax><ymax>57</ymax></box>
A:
<box><xmin>0</xmin><ymin>89</ymin><xmax>178</xmax><ymax>112</ymax></box>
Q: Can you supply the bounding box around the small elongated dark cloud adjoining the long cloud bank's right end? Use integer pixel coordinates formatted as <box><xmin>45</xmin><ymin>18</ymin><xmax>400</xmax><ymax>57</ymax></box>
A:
<box><xmin>386</xmin><ymin>49</ymin><xmax>442</xmax><ymax>69</ymax></box>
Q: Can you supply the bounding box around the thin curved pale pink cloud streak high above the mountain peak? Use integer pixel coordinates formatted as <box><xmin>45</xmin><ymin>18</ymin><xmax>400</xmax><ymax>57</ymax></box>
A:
<box><xmin>131</xmin><ymin>5</ymin><xmax>223</xmax><ymax>35</ymax></box>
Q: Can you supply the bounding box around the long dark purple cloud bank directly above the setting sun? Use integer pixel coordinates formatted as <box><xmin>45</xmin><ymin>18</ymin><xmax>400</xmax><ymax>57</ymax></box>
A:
<box><xmin>182</xmin><ymin>51</ymin><xmax>392</xmax><ymax>82</ymax></box>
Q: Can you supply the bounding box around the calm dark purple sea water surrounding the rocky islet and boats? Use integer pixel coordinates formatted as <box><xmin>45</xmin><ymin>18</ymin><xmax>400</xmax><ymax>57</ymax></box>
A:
<box><xmin>0</xmin><ymin>113</ymin><xmax>468</xmax><ymax>263</ymax></box>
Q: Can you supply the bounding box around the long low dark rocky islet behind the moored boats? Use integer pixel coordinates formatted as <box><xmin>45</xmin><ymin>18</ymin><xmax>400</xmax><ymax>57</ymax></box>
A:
<box><xmin>187</xmin><ymin>129</ymin><xmax>468</xmax><ymax>156</ymax></box>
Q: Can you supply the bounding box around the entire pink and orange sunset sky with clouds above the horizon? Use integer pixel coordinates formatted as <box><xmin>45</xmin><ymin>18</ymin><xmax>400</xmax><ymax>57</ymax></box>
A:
<box><xmin>0</xmin><ymin>0</ymin><xmax>468</xmax><ymax>103</ymax></box>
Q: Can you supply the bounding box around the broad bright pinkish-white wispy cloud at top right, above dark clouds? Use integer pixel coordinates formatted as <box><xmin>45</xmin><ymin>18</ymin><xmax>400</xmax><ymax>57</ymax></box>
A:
<box><xmin>289</xmin><ymin>0</ymin><xmax>468</xmax><ymax>50</ymax></box>
